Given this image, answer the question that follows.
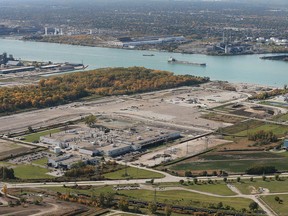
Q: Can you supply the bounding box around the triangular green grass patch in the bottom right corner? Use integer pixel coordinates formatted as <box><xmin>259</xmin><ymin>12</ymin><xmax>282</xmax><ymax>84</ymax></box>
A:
<box><xmin>261</xmin><ymin>195</ymin><xmax>288</xmax><ymax>216</ymax></box>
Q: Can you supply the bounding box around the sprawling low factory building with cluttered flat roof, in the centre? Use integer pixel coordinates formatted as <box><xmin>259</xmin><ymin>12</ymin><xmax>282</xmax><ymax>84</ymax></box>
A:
<box><xmin>40</xmin><ymin>123</ymin><xmax>180</xmax><ymax>157</ymax></box>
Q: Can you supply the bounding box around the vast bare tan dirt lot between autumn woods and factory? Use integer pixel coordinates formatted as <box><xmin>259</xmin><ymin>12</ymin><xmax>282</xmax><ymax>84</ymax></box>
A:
<box><xmin>0</xmin><ymin>82</ymin><xmax>247</xmax><ymax>134</ymax></box>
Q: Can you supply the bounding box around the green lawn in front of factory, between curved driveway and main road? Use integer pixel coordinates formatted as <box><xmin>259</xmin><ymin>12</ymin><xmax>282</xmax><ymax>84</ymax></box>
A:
<box><xmin>104</xmin><ymin>167</ymin><xmax>164</xmax><ymax>179</ymax></box>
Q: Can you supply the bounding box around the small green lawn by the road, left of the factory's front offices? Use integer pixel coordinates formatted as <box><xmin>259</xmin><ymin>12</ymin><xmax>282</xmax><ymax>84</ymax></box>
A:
<box><xmin>14</xmin><ymin>165</ymin><xmax>54</xmax><ymax>179</ymax></box>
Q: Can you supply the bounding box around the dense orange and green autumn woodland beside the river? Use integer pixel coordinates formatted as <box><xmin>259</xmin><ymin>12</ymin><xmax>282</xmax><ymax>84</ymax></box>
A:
<box><xmin>0</xmin><ymin>67</ymin><xmax>209</xmax><ymax>113</ymax></box>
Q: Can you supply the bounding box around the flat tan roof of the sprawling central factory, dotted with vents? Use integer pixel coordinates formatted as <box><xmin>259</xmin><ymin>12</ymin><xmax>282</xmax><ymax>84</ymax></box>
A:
<box><xmin>45</xmin><ymin>123</ymin><xmax>180</xmax><ymax>154</ymax></box>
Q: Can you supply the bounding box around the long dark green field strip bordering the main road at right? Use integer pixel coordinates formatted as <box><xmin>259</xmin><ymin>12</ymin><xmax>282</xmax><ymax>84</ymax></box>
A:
<box><xmin>169</xmin><ymin>158</ymin><xmax>288</xmax><ymax>173</ymax></box>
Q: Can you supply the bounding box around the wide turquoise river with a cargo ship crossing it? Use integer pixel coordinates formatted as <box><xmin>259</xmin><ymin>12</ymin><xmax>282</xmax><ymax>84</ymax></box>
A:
<box><xmin>0</xmin><ymin>39</ymin><xmax>288</xmax><ymax>87</ymax></box>
